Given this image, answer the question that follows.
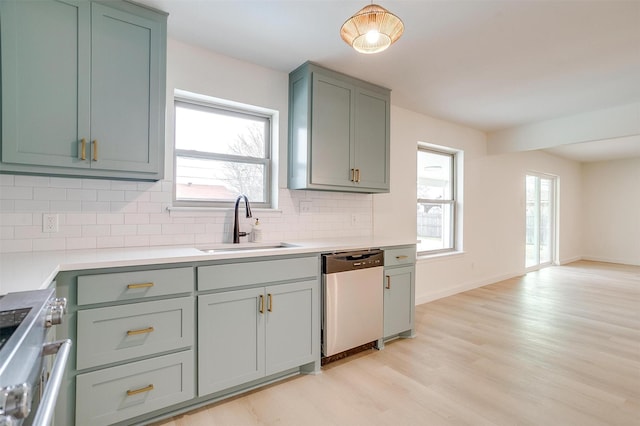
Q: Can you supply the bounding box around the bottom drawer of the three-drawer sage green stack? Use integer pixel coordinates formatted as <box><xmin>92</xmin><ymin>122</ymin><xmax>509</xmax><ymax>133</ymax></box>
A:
<box><xmin>76</xmin><ymin>350</ymin><xmax>195</xmax><ymax>426</ymax></box>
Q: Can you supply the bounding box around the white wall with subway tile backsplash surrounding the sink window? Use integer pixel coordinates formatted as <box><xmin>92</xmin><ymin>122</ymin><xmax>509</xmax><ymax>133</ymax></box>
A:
<box><xmin>0</xmin><ymin>39</ymin><xmax>372</xmax><ymax>253</ymax></box>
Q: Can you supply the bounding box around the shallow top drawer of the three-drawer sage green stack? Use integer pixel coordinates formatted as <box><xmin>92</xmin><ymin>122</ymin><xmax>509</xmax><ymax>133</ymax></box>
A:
<box><xmin>78</xmin><ymin>268</ymin><xmax>193</xmax><ymax>305</ymax></box>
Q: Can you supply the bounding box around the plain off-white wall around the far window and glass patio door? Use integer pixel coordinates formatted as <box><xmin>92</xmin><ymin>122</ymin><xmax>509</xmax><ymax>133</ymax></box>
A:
<box><xmin>374</xmin><ymin>107</ymin><xmax>581</xmax><ymax>303</ymax></box>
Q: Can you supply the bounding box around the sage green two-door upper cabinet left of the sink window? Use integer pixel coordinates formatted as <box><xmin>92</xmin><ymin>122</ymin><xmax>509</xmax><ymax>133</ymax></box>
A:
<box><xmin>0</xmin><ymin>0</ymin><xmax>166</xmax><ymax>180</ymax></box>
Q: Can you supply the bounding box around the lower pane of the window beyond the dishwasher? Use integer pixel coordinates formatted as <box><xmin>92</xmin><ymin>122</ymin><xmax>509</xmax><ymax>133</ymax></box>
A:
<box><xmin>418</xmin><ymin>203</ymin><xmax>453</xmax><ymax>252</ymax></box>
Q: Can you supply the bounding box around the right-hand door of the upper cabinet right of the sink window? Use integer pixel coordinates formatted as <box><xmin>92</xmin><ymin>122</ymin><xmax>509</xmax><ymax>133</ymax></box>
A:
<box><xmin>354</xmin><ymin>89</ymin><xmax>390</xmax><ymax>190</ymax></box>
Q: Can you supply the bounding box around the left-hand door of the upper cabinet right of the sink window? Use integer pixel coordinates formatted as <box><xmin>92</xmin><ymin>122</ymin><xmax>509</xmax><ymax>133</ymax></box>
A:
<box><xmin>309</xmin><ymin>72</ymin><xmax>354</xmax><ymax>186</ymax></box>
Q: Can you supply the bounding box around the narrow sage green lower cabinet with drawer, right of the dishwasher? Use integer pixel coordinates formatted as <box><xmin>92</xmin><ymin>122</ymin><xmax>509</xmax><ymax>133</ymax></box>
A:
<box><xmin>383</xmin><ymin>245</ymin><xmax>416</xmax><ymax>340</ymax></box>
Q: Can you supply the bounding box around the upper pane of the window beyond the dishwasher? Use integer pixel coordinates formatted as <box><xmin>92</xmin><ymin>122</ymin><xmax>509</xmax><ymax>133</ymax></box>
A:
<box><xmin>418</xmin><ymin>150</ymin><xmax>453</xmax><ymax>200</ymax></box>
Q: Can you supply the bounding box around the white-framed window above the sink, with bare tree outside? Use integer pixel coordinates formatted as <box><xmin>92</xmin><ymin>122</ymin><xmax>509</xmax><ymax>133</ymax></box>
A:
<box><xmin>174</xmin><ymin>91</ymin><xmax>276</xmax><ymax>207</ymax></box>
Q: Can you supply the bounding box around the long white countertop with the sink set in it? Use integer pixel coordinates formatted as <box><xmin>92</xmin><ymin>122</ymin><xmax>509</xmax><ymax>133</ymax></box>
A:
<box><xmin>0</xmin><ymin>238</ymin><xmax>415</xmax><ymax>295</ymax></box>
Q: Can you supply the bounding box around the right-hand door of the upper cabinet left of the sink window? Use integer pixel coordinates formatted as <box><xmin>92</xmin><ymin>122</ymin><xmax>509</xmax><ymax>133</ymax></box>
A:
<box><xmin>91</xmin><ymin>3</ymin><xmax>164</xmax><ymax>172</ymax></box>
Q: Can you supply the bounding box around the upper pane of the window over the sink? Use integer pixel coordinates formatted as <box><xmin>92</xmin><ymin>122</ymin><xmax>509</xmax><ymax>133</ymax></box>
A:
<box><xmin>175</xmin><ymin>103</ymin><xmax>268</xmax><ymax>158</ymax></box>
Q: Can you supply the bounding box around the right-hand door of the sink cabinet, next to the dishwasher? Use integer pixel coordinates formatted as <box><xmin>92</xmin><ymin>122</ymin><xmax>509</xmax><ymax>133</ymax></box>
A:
<box><xmin>266</xmin><ymin>280</ymin><xmax>319</xmax><ymax>375</ymax></box>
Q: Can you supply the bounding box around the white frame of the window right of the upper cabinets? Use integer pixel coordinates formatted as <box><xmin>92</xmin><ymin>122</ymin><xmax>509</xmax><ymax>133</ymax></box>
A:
<box><xmin>416</xmin><ymin>144</ymin><xmax>459</xmax><ymax>256</ymax></box>
